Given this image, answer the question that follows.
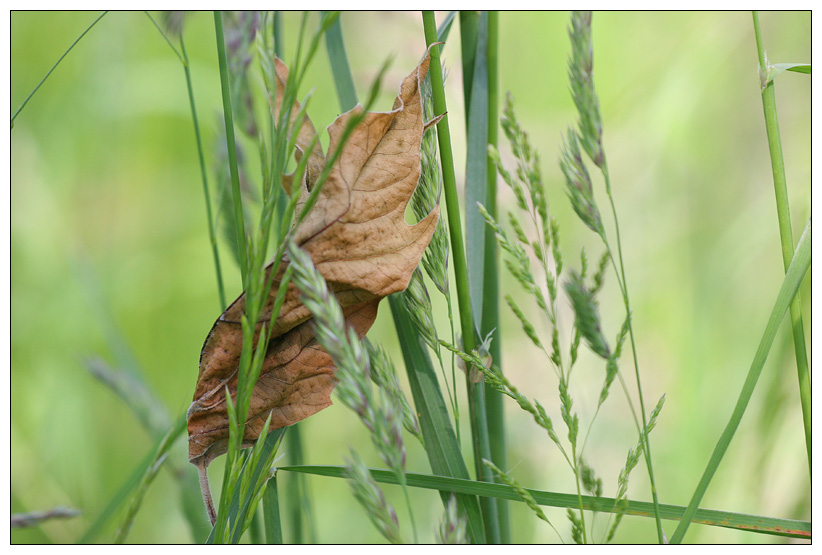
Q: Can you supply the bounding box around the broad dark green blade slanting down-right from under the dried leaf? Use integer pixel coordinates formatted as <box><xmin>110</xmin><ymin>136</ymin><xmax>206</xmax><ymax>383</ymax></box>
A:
<box><xmin>388</xmin><ymin>295</ymin><xmax>485</xmax><ymax>543</ymax></box>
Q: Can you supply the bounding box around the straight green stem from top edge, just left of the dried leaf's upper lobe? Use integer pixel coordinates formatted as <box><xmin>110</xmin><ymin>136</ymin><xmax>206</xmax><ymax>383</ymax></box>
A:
<box><xmin>214</xmin><ymin>11</ymin><xmax>248</xmax><ymax>289</ymax></box>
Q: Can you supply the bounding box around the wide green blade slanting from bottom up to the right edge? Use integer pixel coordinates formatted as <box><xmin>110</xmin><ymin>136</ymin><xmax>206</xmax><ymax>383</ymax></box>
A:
<box><xmin>671</xmin><ymin>219</ymin><xmax>811</xmax><ymax>543</ymax></box>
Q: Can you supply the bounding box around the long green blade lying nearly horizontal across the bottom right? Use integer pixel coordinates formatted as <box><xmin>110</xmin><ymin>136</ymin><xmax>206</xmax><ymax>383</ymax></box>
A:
<box><xmin>278</xmin><ymin>466</ymin><xmax>811</xmax><ymax>539</ymax></box>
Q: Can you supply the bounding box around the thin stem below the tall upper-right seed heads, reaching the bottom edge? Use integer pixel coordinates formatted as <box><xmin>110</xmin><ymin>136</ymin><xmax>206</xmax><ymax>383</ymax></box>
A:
<box><xmin>602</xmin><ymin>168</ymin><xmax>665</xmax><ymax>543</ymax></box>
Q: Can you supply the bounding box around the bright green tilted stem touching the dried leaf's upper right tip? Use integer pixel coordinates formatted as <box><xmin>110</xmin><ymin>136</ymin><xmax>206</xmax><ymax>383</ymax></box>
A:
<box><xmin>422</xmin><ymin>11</ymin><xmax>499</xmax><ymax>543</ymax></box>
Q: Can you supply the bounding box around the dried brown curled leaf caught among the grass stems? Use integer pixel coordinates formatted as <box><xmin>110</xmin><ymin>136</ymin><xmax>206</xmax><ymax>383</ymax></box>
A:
<box><xmin>188</xmin><ymin>56</ymin><xmax>439</xmax><ymax>468</ymax></box>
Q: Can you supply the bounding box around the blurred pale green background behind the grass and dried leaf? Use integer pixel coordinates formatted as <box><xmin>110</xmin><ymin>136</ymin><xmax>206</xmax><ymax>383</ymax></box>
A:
<box><xmin>10</xmin><ymin>12</ymin><xmax>811</xmax><ymax>543</ymax></box>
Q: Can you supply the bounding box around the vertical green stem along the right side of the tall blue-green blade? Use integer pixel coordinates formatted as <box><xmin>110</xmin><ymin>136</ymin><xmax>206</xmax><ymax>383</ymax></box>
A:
<box><xmin>480</xmin><ymin>11</ymin><xmax>511</xmax><ymax>543</ymax></box>
